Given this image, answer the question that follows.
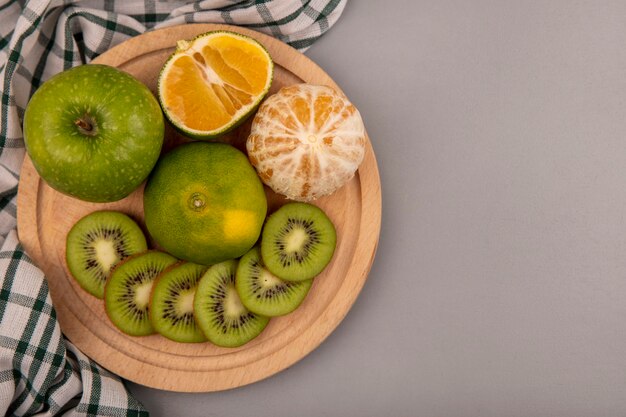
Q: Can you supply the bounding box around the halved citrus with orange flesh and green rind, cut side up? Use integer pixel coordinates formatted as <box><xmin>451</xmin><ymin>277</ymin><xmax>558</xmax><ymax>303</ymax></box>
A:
<box><xmin>158</xmin><ymin>31</ymin><xmax>274</xmax><ymax>139</ymax></box>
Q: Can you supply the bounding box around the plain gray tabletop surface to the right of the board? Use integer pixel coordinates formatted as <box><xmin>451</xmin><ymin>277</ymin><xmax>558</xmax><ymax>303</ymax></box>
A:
<box><xmin>131</xmin><ymin>0</ymin><xmax>626</xmax><ymax>417</ymax></box>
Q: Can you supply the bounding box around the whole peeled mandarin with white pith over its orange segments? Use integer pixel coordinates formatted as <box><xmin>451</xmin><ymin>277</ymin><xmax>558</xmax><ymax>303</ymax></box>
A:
<box><xmin>246</xmin><ymin>84</ymin><xmax>366</xmax><ymax>201</ymax></box>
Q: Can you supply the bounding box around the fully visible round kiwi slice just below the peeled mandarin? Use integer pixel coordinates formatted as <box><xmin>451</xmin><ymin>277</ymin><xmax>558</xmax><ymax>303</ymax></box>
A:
<box><xmin>261</xmin><ymin>203</ymin><xmax>337</xmax><ymax>281</ymax></box>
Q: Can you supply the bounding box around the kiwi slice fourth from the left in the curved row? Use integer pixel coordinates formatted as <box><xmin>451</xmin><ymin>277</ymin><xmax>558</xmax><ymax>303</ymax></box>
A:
<box><xmin>194</xmin><ymin>260</ymin><xmax>269</xmax><ymax>347</ymax></box>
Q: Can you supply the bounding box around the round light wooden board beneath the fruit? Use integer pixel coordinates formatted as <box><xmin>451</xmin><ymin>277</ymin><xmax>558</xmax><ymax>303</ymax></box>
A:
<box><xmin>18</xmin><ymin>24</ymin><xmax>381</xmax><ymax>392</ymax></box>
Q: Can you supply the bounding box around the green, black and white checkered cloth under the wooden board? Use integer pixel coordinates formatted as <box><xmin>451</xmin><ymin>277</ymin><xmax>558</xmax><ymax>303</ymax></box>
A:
<box><xmin>0</xmin><ymin>0</ymin><xmax>347</xmax><ymax>416</ymax></box>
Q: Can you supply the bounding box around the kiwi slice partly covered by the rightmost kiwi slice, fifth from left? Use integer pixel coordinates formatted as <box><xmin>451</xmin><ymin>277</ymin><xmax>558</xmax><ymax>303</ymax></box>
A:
<box><xmin>235</xmin><ymin>247</ymin><xmax>313</xmax><ymax>317</ymax></box>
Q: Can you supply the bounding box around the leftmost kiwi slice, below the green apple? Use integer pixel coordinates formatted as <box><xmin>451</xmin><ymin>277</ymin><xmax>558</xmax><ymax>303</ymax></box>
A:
<box><xmin>65</xmin><ymin>211</ymin><xmax>148</xmax><ymax>298</ymax></box>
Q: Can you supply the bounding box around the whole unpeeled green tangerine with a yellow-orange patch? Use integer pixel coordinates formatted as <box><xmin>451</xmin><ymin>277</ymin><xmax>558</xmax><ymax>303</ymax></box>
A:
<box><xmin>143</xmin><ymin>142</ymin><xmax>267</xmax><ymax>265</ymax></box>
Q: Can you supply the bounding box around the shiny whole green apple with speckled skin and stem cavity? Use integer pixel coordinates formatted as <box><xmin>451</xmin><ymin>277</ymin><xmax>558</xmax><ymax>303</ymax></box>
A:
<box><xmin>24</xmin><ymin>64</ymin><xmax>164</xmax><ymax>202</ymax></box>
